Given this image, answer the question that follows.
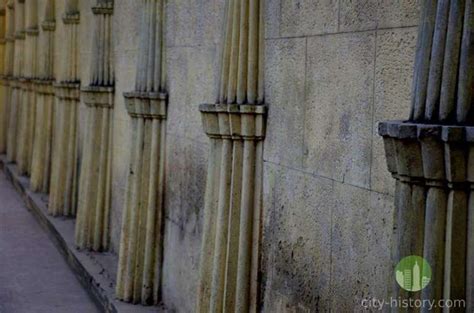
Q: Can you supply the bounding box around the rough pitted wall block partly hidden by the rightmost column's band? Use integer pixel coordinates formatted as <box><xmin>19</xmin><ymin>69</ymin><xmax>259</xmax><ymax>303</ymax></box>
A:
<box><xmin>371</xmin><ymin>27</ymin><xmax>417</xmax><ymax>194</ymax></box>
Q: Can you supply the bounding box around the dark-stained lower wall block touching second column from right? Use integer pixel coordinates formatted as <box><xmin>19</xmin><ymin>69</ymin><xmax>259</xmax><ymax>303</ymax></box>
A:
<box><xmin>262</xmin><ymin>163</ymin><xmax>334</xmax><ymax>312</ymax></box>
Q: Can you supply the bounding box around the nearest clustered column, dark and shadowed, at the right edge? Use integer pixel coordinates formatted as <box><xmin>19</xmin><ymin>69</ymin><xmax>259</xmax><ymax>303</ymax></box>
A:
<box><xmin>379</xmin><ymin>0</ymin><xmax>474</xmax><ymax>312</ymax></box>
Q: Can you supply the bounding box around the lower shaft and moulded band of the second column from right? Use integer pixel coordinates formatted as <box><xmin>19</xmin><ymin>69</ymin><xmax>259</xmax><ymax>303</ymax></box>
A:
<box><xmin>198</xmin><ymin>104</ymin><xmax>266</xmax><ymax>312</ymax></box>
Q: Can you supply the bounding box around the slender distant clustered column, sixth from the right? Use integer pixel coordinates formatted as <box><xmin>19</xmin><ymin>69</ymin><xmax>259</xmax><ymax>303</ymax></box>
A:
<box><xmin>30</xmin><ymin>0</ymin><xmax>56</xmax><ymax>193</ymax></box>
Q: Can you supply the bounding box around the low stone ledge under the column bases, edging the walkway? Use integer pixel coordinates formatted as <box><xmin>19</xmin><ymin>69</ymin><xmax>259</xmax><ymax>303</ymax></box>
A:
<box><xmin>0</xmin><ymin>155</ymin><xmax>168</xmax><ymax>313</ymax></box>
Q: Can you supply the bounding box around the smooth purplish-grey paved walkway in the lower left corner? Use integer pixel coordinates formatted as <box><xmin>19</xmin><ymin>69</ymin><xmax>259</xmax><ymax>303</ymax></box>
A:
<box><xmin>0</xmin><ymin>171</ymin><xmax>99</xmax><ymax>313</ymax></box>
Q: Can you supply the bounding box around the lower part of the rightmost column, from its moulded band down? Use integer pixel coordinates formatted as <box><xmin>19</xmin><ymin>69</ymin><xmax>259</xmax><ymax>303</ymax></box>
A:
<box><xmin>379</xmin><ymin>121</ymin><xmax>474</xmax><ymax>303</ymax></box>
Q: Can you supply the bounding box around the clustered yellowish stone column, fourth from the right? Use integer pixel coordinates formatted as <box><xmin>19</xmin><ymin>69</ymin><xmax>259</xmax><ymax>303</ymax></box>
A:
<box><xmin>76</xmin><ymin>0</ymin><xmax>115</xmax><ymax>251</ymax></box>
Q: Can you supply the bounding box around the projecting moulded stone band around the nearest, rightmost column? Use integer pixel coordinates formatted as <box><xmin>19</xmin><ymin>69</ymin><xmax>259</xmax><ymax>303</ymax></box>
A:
<box><xmin>378</xmin><ymin>121</ymin><xmax>474</xmax><ymax>185</ymax></box>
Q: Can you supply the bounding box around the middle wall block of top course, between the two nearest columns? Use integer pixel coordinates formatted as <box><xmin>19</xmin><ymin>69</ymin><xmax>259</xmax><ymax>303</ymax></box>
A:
<box><xmin>280</xmin><ymin>0</ymin><xmax>339</xmax><ymax>37</ymax></box>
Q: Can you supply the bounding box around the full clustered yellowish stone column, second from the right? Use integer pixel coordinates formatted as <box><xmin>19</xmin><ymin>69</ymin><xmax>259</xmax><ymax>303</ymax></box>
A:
<box><xmin>196</xmin><ymin>0</ymin><xmax>266</xmax><ymax>312</ymax></box>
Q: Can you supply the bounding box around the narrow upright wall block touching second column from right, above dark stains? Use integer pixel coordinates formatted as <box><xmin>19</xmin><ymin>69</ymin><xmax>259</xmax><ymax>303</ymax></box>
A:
<box><xmin>264</xmin><ymin>38</ymin><xmax>306</xmax><ymax>168</ymax></box>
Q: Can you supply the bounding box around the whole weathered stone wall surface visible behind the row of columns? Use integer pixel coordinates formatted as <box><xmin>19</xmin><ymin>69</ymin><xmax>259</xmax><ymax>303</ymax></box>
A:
<box><xmin>63</xmin><ymin>0</ymin><xmax>418</xmax><ymax>312</ymax></box>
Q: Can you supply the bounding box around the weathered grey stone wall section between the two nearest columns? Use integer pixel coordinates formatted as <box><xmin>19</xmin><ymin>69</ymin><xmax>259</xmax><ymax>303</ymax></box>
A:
<box><xmin>262</xmin><ymin>0</ymin><xmax>419</xmax><ymax>312</ymax></box>
